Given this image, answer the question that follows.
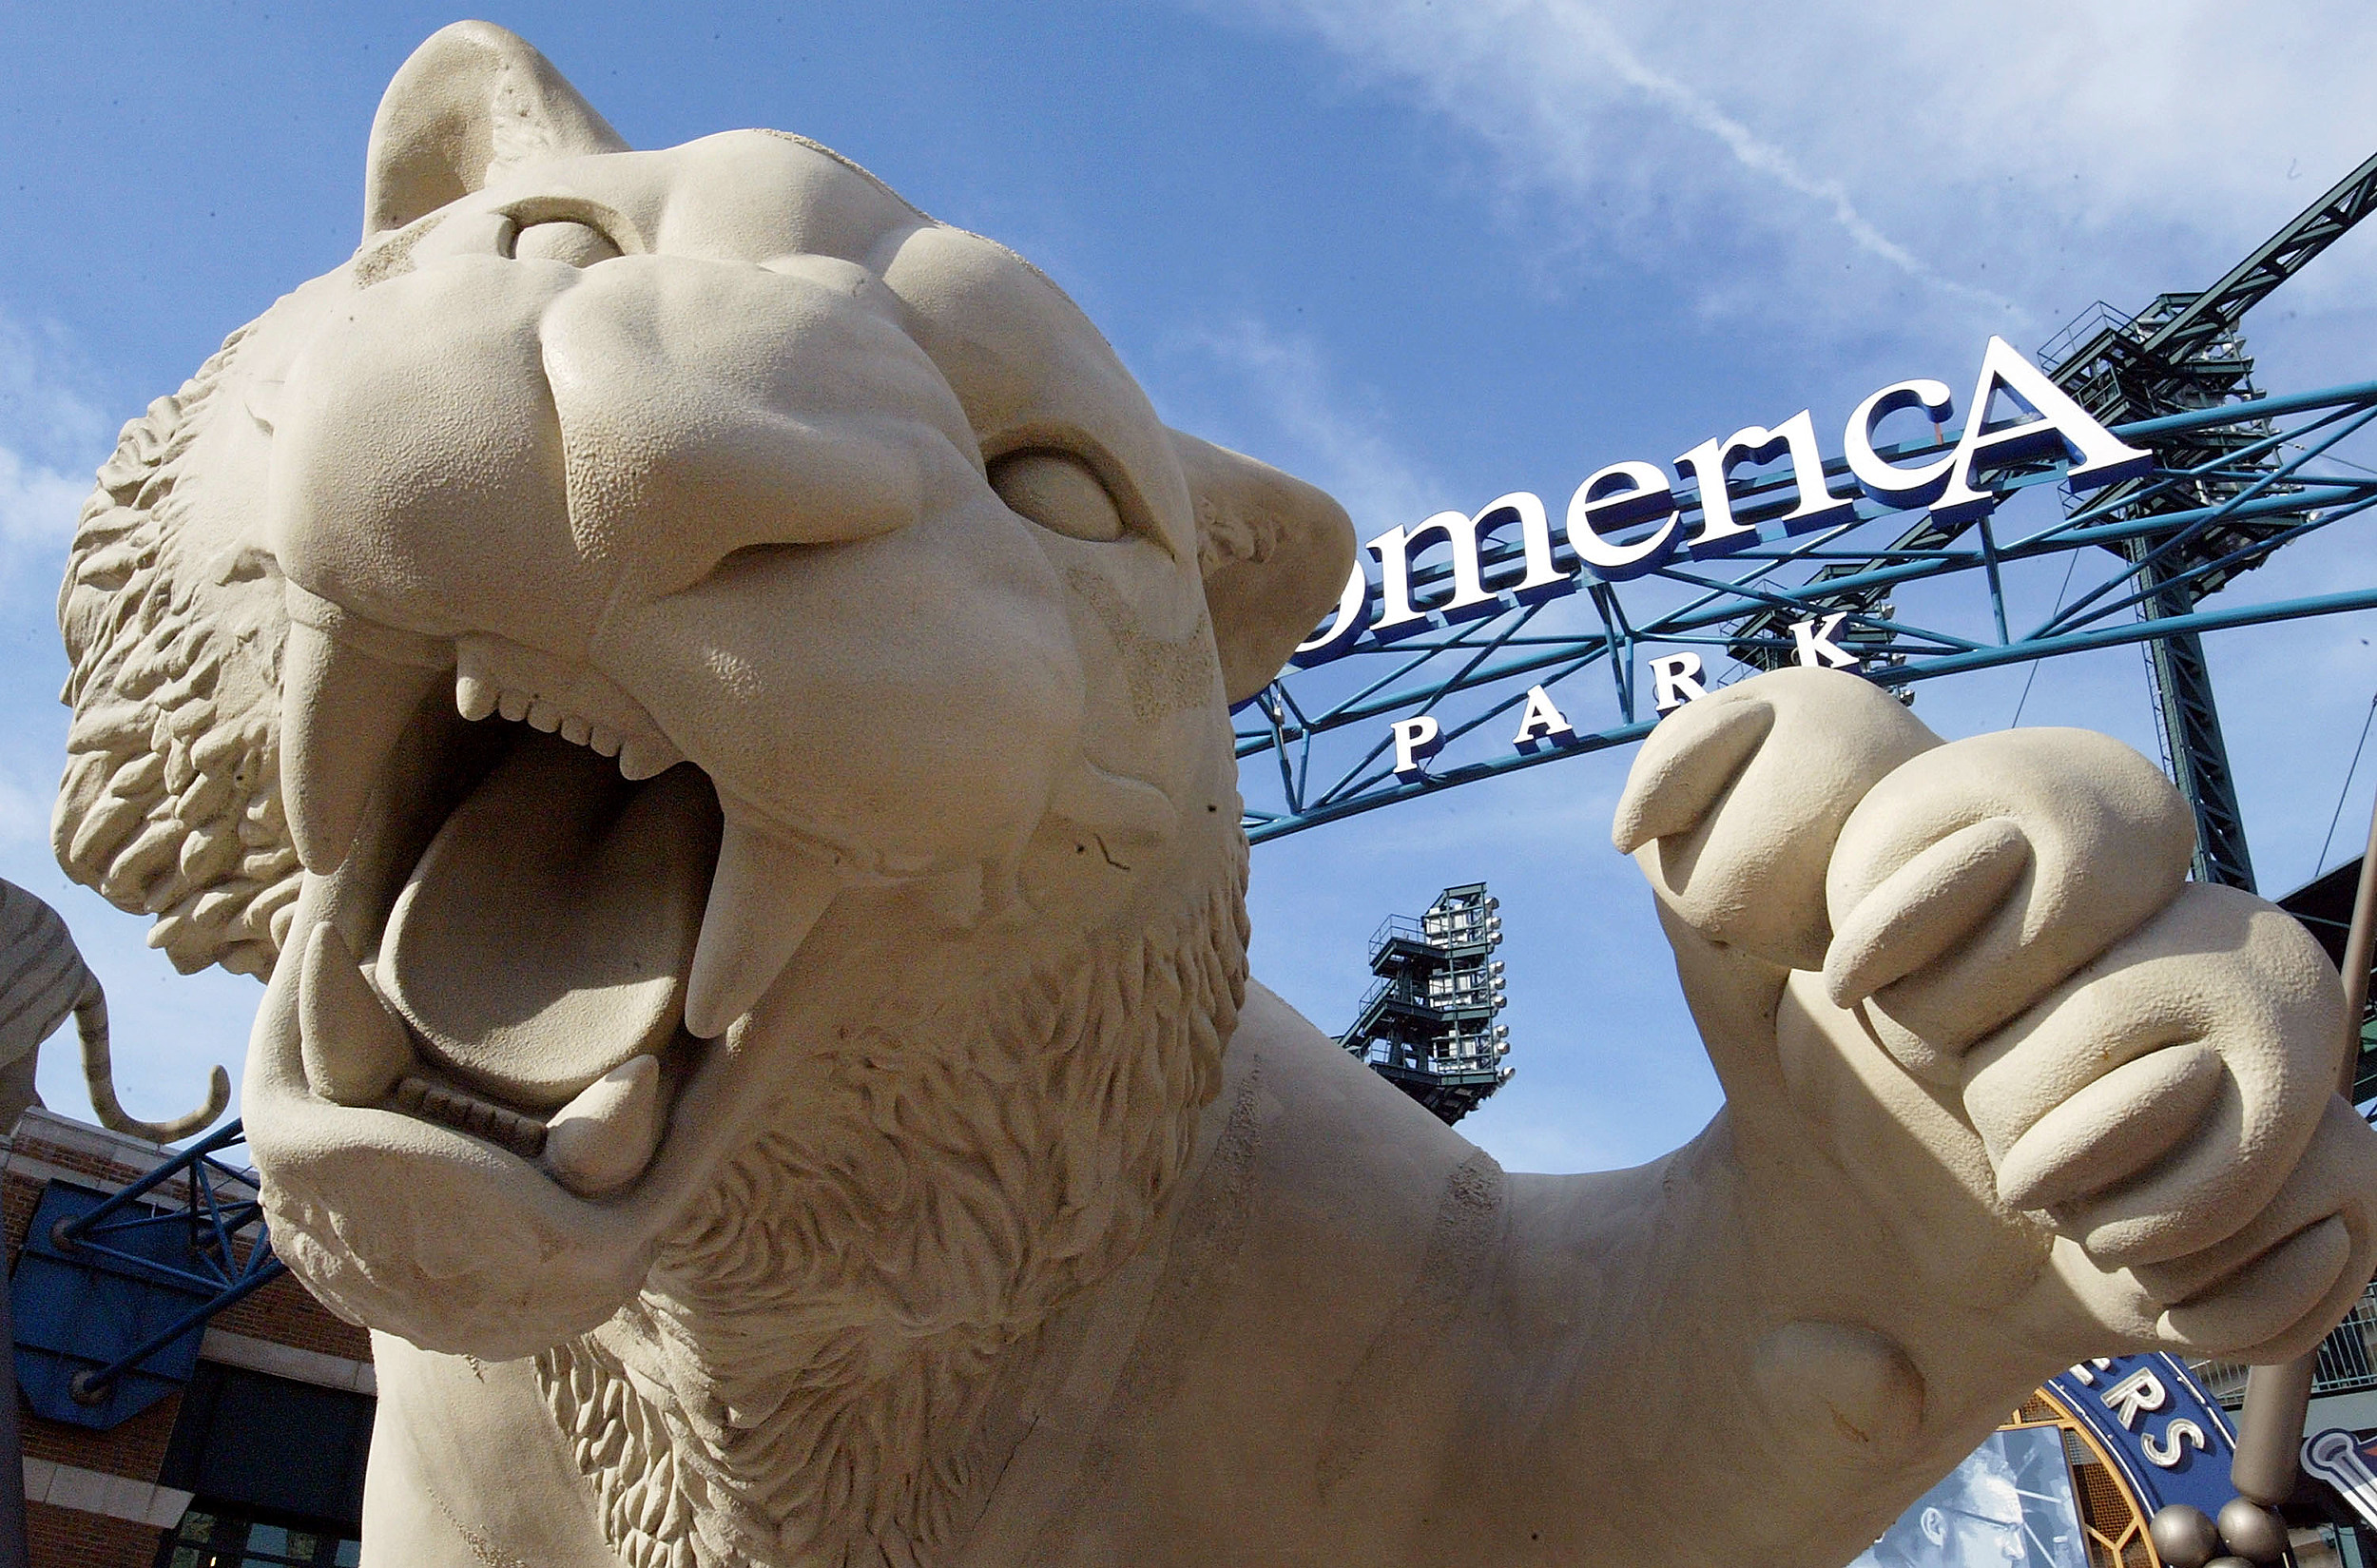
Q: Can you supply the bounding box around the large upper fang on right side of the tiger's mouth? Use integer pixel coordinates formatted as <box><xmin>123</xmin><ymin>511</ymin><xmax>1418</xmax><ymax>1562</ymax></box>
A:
<box><xmin>685</xmin><ymin>807</ymin><xmax>841</xmax><ymax>1040</ymax></box>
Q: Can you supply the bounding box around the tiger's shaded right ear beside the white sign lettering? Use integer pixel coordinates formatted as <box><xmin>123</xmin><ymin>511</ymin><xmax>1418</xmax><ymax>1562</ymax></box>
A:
<box><xmin>1172</xmin><ymin>430</ymin><xmax>1353</xmax><ymax>704</ymax></box>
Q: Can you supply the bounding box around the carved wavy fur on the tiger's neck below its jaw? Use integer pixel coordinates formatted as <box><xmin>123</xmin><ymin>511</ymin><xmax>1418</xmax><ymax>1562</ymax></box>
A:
<box><xmin>537</xmin><ymin>864</ymin><xmax>1248</xmax><ymax>1568</ymax></box>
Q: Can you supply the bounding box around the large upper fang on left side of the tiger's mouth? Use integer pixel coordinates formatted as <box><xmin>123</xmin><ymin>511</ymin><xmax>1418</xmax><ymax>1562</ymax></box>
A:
<box><xmin>280</xmin><ymin>620</ymin><xmax>445</xmax><ymax>874</ymax></box>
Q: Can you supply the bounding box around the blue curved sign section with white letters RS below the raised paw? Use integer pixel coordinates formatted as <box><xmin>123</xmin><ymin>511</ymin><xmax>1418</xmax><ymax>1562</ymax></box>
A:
<box><xmin>2047</xmin><ymin>1352</ymin><xmax>2237</xmax><ymax>1519</ymax></box>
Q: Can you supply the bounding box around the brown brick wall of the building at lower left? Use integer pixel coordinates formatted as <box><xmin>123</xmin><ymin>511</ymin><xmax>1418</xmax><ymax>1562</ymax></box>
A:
<box><xmin>0</xmin><ymin>1110</ymin><xmax>374</xmax><ymax>1568</ymax></box>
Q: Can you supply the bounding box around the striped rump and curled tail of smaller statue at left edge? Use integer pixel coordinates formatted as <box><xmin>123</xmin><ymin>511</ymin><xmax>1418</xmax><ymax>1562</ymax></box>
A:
<box><xmin>0</xmin><ymin>881</ymin><xmax>231</xmax><ymax>1143</ymax></box>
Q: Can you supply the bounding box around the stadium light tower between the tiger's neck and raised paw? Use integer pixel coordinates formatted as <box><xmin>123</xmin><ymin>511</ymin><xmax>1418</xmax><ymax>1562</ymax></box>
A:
<box><xmin>1339</xmin><ymin>881</ymin><xmax>1517</xmax><ymax>1126</ymax></box>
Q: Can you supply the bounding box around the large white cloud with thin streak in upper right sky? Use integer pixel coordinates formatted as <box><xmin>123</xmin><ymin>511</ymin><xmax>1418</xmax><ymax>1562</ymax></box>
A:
<box><xmin>1206</xmin><ymin>0</ymin><xmax>2377</xmax><ymax>356</ymax></box>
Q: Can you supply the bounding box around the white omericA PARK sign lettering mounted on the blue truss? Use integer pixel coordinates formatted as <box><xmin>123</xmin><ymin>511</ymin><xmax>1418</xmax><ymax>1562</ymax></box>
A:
<box><xmin>1296</xmin><ymin>338</ymin><xmax>2154</xmax><ymax>780</ymax></box>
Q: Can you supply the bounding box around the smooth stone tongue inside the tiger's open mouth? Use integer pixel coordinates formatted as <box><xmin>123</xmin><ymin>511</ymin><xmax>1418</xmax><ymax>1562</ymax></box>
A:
<box><xmin>378</xmin><ymin>732</ymin><xmax>718</xmax><ymax>1110</ymax></box>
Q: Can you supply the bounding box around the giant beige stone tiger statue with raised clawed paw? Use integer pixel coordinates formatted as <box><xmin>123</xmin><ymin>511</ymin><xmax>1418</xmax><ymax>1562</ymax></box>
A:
<box><xmin>57</xmin><ymin>24</ymin><xmax>2377</xmax><ymax>1568</ymax></box>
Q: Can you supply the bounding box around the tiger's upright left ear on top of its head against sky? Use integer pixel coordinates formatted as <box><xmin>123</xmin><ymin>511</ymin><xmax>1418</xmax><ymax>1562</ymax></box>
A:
<box><xmin>364</xmin><ymin>21</ymin><xmax>628</xmax><ymax>242</ymax></box>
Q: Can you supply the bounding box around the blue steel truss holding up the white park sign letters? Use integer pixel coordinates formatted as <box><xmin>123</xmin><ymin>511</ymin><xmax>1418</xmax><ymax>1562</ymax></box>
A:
<box><xmin>1236</xmin><ymin>382</ymin><xmax>2377</xmax><ymax>841</ymax></box>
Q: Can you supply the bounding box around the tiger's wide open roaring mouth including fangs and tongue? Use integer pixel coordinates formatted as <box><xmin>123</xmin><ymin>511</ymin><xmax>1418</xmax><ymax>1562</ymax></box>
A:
<box><xmin>283</xmin><ymin>591</ymin><xmax>846</xmax><ymax>1197</ymax></box>
